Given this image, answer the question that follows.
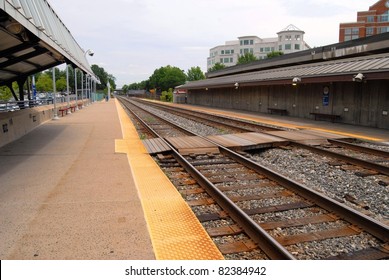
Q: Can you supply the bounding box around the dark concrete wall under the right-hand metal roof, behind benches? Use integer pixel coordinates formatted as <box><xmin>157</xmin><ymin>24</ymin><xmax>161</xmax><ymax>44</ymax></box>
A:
<box><xmin>188</xmin><ymin>80</ymin><xmax>389</xmax><ymax>129</ymax></box>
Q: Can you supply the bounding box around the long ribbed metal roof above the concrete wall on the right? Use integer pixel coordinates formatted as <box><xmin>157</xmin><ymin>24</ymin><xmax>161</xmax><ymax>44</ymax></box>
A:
<box><xmin>179</xmin><ymin>53</ymin><xmax>389</xmax><ymax>89</ymax></box>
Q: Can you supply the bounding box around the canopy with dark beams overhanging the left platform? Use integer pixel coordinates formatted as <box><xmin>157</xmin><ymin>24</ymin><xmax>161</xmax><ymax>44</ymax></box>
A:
<box><xmin>0</xmin><ymin>0</ymin><xmax>96</xmax><ymax>86</ymax></box>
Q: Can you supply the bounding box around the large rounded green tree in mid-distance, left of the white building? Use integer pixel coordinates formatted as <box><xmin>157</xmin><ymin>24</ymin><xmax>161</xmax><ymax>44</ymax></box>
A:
<box><xmin>149</xmin><ymin>65</ymin><xmax>186</xmax><ymax>92</ymax></box>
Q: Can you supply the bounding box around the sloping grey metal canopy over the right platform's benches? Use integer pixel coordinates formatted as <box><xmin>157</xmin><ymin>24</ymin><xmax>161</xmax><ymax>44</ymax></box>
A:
<box><xmin>180</xmin><ymin>53</ymin><xmax>389</xmax><ymax>90</ymax></box>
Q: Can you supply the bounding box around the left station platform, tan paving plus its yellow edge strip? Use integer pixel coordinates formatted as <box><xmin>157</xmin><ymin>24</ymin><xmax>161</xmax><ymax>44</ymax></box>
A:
<box><xmin>0</xmin><ymin>100</ymin><xmax>222</xmax><ymax>260</ymax></box>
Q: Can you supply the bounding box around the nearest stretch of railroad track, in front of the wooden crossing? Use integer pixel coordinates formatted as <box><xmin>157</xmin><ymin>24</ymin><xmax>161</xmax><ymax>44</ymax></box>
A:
<box><xmin>117</xmin><ymin>96</ymin><xmax>389</xmax><ymax>259</ymax></box>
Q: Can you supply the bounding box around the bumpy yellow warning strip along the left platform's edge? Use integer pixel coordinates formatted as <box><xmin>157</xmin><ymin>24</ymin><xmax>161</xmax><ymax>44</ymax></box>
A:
<box><xmin>115</xmin><ymin>100</ymin><xmax>224</xmax><ymax>260</ymax></box>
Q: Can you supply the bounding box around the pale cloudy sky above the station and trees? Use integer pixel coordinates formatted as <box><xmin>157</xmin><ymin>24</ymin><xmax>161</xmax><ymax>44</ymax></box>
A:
<box><xmin>48</xmin><ymin>0</ymin><xmax>370</xmax><ymax>87</ymax></box>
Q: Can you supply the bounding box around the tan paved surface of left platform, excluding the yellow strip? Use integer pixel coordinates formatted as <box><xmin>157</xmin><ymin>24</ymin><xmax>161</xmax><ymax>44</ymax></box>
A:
<box><xmin>0</xmin><ymin>100</ymin><xmax>155</xmax><ymax>260</ymax></box>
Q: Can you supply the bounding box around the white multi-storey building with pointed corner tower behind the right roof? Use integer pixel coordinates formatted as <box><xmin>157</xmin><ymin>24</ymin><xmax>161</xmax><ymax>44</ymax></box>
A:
<box><xmin>207</xmin><ymin>24</ymin><xmax>310</xmax><ymax>69</ymax></box>
